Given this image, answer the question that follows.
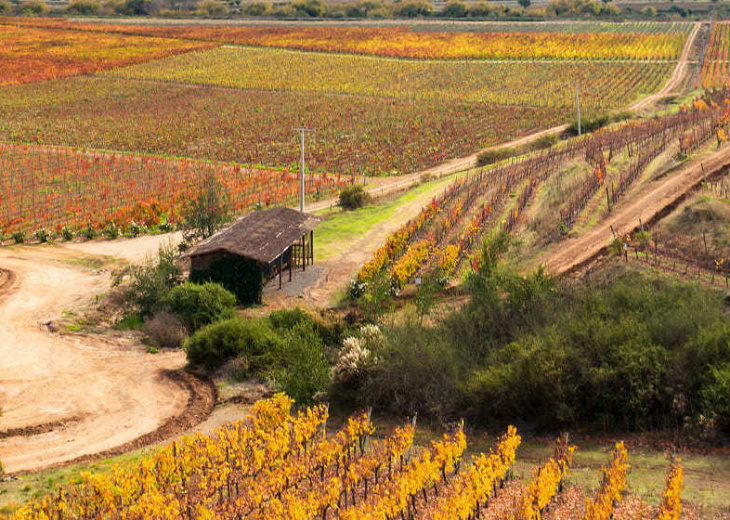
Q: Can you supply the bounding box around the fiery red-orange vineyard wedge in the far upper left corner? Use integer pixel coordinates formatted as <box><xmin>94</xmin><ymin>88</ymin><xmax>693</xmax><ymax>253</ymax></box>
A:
<box><xmin>0</xmin><ymin>22</ymin><xmax>212</xmax><ymax>87</ymax></box>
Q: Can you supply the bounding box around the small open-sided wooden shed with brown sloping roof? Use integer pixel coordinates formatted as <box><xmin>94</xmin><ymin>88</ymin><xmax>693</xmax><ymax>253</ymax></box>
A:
<box><xmin>186</xmin><ymin>208</ymin><xmax>320</xmax><ymax>304</ymax></box>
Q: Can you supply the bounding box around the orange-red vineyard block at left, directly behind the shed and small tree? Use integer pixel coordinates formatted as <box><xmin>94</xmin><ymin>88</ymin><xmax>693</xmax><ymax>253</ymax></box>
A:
<box><xmin>0</xmin><ymin>144</ymin><xmax>351</xmax><ymax>236</ymax></box>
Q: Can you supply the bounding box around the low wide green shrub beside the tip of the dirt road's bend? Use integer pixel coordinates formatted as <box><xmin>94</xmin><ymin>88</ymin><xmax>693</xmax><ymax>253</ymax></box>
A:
<box><xmin>183</xmin><ymin>318</ymin><xmax>282</xmax><ymax>371</ymax></box>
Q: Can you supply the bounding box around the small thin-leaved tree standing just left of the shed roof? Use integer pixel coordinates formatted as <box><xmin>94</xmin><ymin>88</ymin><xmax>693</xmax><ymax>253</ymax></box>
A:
<box><xmin>183</xmin><ymin>175</ymin><xmax>230</xmax><ymax>238</ymax></box>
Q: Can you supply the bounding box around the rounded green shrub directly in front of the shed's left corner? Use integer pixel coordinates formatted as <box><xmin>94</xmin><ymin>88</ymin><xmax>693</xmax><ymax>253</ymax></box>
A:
<box><xmin>164</xmin><ymin>282</ymin><xmax>236</xmax><ymax>332</ymax></box>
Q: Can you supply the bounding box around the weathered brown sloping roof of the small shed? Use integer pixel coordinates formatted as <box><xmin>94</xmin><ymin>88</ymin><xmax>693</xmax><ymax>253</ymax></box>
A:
<box><xmin>186</xmin><ymin>208</ymin><xmax>320</xmax><ymax>264</ymax></box>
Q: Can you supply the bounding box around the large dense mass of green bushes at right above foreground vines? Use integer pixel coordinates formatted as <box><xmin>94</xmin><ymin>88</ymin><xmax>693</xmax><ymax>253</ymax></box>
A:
<box><xmin>350</xmin><ymin>254</ymin><xmax>730</xmax><ymax>433</ymax></box>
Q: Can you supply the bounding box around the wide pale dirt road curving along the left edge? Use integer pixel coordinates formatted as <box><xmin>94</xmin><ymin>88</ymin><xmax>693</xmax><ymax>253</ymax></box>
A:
<box><xmin>0</xmin><ymin>237</ymin><xmax>190</xmax><ymax>473</ymax></box>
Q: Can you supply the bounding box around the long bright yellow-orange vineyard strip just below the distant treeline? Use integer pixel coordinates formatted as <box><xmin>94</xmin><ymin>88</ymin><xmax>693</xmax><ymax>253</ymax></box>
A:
<box><xmin>0</xmin><ymin>21</ymin><xmax>690</xmax><ymax>60</ymax></box>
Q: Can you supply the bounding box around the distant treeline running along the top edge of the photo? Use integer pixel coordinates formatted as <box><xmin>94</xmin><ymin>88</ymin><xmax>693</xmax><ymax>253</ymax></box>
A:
<box><xmin>7</xmin><ymin>0</ymin><xmax>730</xmax><ymax>20</ymax></box>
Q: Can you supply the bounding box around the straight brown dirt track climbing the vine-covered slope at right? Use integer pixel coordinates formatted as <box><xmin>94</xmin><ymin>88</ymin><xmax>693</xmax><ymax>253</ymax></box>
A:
<box><xmin>538</xmin><ymin>140</ymin><xmax>730</xmax><ymax>275</ymax></box>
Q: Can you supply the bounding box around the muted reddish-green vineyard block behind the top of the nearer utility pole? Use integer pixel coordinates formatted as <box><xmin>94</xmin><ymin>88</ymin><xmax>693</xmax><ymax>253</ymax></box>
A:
<box><xmin>0</xmin><ymin>77</ymin><xmax>567</xmax><ymax>175</ymax></box>
